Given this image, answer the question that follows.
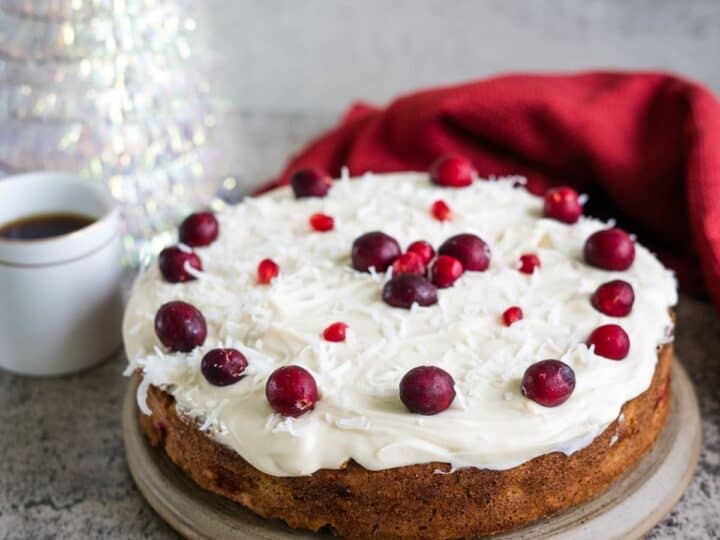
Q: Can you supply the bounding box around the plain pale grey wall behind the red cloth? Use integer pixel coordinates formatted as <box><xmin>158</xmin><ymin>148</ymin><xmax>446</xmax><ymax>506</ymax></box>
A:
<box><xmin>202</xmin><ymin>0</ymin><xmax>720</xmax><ymax>190</ymax></box>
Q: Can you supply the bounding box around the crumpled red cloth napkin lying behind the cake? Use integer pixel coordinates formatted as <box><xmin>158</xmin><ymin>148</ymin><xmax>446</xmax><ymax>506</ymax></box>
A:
<box><xmin>265</xmin><ymin>72</ymin><xmax>720</xmax><ymax>307</ymax></box>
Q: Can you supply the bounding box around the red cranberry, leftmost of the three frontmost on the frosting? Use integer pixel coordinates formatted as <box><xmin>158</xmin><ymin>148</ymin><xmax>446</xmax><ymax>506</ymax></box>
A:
<box><xmin>265</xmin><ymin>366</ymin><xmax>318</xmax><ymax>417</ymax></box>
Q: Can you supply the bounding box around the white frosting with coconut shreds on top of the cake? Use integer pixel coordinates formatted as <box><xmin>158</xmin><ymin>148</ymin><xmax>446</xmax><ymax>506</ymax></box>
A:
<box><xmin>124</xmin><ymin>173</ymin><xmax>676</xmax><ymax>476</ymax></box>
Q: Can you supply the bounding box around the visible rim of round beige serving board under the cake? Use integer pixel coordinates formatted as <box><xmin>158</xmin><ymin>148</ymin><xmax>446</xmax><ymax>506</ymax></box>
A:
<box><xmin>123</xmin><ymin>360</ymin><xmax>701</xmax><ymax>540</ymax></box>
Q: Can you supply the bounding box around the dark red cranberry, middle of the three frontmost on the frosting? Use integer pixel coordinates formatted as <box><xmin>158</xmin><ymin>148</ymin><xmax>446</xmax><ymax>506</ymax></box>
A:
<box><xmin>400</xmin><ymin>366</ymin><xmax>455</xmax><ymax>415</ymax></box>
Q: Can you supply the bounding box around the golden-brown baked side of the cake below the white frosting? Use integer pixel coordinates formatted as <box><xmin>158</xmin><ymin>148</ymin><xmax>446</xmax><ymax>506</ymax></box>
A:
<box><xmin>140</xmin><ymin>343</ymin><xmax>673</xmax><ymax>540</ymax></box>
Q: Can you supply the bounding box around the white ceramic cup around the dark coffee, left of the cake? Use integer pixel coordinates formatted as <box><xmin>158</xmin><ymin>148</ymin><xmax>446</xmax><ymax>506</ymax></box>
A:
<box><xmin>0</xmin><ymin>173</ymin><xmax>122</xmax><ymax>375</ymax></box>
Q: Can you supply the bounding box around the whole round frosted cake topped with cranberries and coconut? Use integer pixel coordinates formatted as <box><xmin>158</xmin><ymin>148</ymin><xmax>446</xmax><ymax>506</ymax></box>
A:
<box><xmin>123</xmin><ymin>158</ymin><xmax>677</xmax><ymax>539</ymax></box>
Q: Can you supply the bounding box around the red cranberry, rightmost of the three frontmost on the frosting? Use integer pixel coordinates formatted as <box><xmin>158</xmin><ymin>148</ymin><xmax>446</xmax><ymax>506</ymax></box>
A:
<box><xmin>520</xmin><ymin>360</ymin><xmax>575</xmax><ymax>407</ymax></box>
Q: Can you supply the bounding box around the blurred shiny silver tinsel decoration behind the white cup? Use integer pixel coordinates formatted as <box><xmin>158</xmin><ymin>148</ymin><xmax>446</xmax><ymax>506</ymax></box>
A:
<box><xmin>0</xmin><ymin>0</ymin><xmax>219</xmax><ymax>262</ymax></box>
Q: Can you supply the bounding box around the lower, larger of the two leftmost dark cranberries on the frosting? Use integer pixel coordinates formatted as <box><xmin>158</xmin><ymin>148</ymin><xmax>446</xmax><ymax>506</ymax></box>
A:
<box><xmin>155</xmin><ymin>301</ymin><xmax>207</xmax><ymax>352</ymax></box>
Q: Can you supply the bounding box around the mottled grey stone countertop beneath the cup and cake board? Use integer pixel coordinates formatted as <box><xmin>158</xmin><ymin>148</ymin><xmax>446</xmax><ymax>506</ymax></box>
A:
<box><xmin>0</xmin><ymin>298</ymin><xmax>720</xmax><ymax>539</ymax></box>
